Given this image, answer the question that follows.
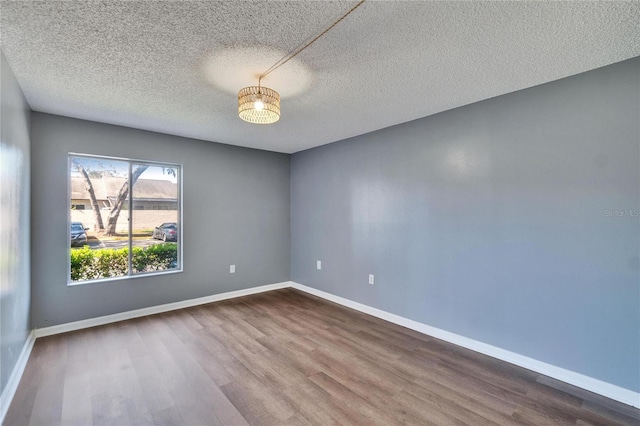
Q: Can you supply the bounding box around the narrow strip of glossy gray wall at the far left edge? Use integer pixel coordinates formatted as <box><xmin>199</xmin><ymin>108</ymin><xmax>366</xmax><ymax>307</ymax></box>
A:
<box><xmin>0</xmin><ymin>51</ymin><xmax>31</xmax><ymax>393</ymax></box>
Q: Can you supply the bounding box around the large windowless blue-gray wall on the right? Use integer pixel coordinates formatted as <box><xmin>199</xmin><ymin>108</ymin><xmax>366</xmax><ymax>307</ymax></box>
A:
<box><xmin>291</xmin><ymin>59</ymin><xmax>640</xmax><ymax>392</ymax></box>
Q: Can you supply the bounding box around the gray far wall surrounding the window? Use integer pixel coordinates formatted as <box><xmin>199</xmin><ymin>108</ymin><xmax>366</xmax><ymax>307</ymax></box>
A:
<box><xmin>31</xmin><ymin>113</ymin><xmax>290</xmax><ymax>327</ymax></box>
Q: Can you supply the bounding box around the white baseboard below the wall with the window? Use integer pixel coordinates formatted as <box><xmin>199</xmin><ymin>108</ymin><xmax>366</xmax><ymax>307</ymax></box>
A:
<box><xmin>34</xmin><ymin>281</ymin><xmax>291</xmax><ymax>337</ymax></box>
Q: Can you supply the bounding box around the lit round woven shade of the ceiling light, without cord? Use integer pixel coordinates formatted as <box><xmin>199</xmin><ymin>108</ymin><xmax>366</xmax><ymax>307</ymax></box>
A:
<box><xmin>238</xmin><ymin>86</ymin><xmax>280</xmax><ymax>124</ymax></box>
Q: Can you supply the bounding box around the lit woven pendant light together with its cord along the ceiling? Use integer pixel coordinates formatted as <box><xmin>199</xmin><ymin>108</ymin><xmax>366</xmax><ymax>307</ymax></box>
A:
<box><xmin>238</xmin><ymin>0</ymin><xmax>365</xmax><ymax>124</ymax></box>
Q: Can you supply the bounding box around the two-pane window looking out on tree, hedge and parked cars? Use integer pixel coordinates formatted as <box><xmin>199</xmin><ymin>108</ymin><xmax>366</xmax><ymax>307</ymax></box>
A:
<box><xmin>67</xmin><ymin>154</ymin><xmax>182</xmax><ymax>284</ymax></box>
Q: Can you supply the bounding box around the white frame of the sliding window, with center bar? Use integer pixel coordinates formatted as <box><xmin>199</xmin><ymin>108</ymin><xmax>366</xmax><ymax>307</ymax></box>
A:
<box><xmin>66</xmin><ymin>152</ymin><xmax>184</xmax><ymax>286</ymax></box>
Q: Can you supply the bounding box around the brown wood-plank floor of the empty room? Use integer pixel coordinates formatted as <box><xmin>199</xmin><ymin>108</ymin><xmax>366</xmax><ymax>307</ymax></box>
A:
<box><xmin>5</xmin><ymin>289</ymin><xmax>640</xmax><ymax>426</ymax></box>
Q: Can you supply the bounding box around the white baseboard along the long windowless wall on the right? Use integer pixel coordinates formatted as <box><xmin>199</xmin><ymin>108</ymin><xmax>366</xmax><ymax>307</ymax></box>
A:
<box><xmin>291</xmin><ymin>282</ymin><xmax>640</xmax><ymax>408</ymax></box>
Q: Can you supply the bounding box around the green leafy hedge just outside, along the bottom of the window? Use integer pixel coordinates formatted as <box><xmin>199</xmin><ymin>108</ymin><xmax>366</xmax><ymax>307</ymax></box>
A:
<box><xmin>71</xmin><ymin>243</ymin><xmax>178</xmax><ymax>281</ymax></box>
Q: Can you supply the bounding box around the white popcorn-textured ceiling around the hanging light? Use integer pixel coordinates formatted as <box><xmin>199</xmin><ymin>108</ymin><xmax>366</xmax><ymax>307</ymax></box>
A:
<box><xmin>0</xmin><ymin>0</ymin><xmax>640</xmax><ymax>153</ymax></box>
